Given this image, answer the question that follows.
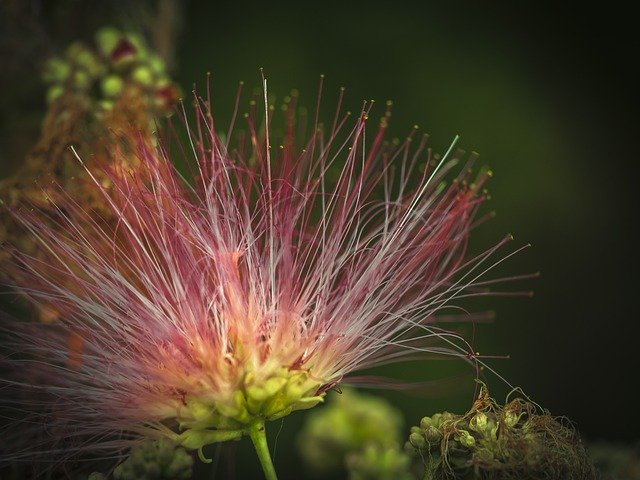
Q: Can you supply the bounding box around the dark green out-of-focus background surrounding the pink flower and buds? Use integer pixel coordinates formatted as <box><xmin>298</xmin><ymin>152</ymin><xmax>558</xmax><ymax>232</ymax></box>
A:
<box><xmin>0</xmin><ymin>0</ymin><xmax>640</xmax><ymax>478</ymax></box>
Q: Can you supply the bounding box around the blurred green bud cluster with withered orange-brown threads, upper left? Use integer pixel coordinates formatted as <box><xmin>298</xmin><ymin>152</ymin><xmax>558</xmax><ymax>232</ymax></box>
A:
<box><xmin>0</xmin><ymin>27</ymin><xmax>180</xmax><ymax>308</ymax></box>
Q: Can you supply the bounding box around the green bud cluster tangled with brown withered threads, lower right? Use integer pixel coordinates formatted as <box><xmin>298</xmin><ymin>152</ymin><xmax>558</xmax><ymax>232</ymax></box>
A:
<box><xmin>405</xmin><ymin>387</ymin><xmax>592</xmax><ymax>479</ymax></box>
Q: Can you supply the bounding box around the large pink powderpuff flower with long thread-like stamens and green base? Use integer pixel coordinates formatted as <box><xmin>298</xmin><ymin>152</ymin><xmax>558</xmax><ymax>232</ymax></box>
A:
<box><xmin>0</xmin><ymin>79</ymin><xmax>524</xmax><ymax>478</ymax></box>
